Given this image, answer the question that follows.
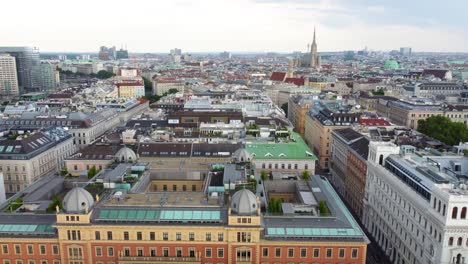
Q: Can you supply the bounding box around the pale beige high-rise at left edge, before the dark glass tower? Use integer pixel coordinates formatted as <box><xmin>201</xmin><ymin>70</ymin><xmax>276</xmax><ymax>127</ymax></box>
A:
<box><xmin>0</xmin><ymin>54</ymin><xmax>19</xmax><ymax>97</ymax></box>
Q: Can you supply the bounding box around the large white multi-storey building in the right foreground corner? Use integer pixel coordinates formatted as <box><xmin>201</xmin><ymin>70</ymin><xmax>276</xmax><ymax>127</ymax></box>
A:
<box><xmin>363</xmin><ymin>142</ymin><xmax>468</xmax><ymax>264</ymax></box>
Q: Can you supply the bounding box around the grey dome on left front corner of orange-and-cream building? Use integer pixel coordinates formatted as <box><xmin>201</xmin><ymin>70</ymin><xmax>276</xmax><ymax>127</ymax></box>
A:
<box><xmin>62</xmin><ymin>187</ymin><xmax>94</xmax><ymax>213</ymax></box>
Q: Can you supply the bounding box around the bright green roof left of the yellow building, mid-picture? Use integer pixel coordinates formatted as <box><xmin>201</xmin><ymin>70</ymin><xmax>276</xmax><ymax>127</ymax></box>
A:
<box><xmin>245</xmin><ymin>132</ymin><xmax>317</xmax><ymax>160</ymax></box>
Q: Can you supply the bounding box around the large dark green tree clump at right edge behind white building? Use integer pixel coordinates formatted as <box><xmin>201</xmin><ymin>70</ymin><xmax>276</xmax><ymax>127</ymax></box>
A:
<box><xmin>418</xmin><ymin>115</ymin><xmax>468</xmax><ymax>146</ymax></box>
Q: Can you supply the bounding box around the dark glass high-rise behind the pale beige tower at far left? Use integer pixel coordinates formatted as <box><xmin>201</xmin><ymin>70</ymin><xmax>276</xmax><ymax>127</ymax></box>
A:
<box><xmin>0</xmin><ymin>47</ymin><xmax>42</xmax><ymax>94</ymax></box>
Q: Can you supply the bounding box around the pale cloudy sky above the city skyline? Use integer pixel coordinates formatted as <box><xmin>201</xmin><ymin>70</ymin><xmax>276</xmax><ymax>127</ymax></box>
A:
<box><xmin>0</xmin><ymin>0</ymin><xmax>468</xmax><ymax>52</ymax></box>
